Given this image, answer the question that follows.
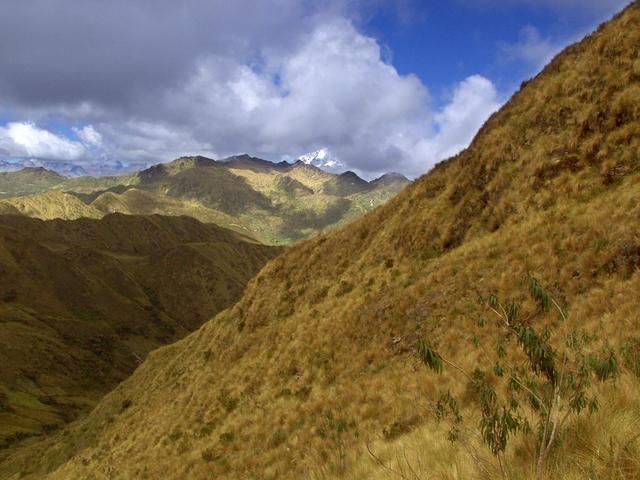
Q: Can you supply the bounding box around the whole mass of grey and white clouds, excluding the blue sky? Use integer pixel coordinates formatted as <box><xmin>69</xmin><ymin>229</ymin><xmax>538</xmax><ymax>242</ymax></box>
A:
<box><xmin>0</xmin><ymin>0</ymin><xmax>500</xmax><ymax>176</ymax></box>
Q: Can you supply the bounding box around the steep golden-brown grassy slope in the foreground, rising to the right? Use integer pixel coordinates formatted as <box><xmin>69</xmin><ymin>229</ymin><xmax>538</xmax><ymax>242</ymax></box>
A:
<box><xmin>0</xmin><ymin>2</ymin><xmax>640</xmax><ymax>479</ymax></box>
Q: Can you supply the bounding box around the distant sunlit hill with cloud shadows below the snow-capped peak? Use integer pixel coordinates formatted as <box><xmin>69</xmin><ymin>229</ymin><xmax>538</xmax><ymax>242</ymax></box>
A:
<box><xmin>86</xmin><ymin>155</ymin><xmax>409</xmax><ymax>244</ymax></box>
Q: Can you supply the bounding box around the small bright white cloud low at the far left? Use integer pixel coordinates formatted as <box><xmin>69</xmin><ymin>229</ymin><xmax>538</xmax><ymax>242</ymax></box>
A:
<box><xmin>0</xmin><ymin>122</ymin><xmax>85</xmax><ymax>161</ymax></box>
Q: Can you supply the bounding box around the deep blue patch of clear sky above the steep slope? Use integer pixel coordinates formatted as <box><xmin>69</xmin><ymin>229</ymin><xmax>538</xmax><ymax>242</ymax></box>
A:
<box><xmin>364</xmin><ymin>0</ymin><xmax>624</xmax><ymax>102</ymax></box>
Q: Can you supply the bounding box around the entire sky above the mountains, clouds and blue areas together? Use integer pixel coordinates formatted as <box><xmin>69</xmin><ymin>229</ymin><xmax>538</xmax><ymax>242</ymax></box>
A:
<box><xmin>0</xmin><ymin>0</ymin><xmax>627</xmax><ymax>178</ymax></box>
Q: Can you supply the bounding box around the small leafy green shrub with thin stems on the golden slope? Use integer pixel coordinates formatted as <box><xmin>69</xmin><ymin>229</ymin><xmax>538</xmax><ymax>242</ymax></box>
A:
<box><xmin>418</xmin><ymin>276</ymin><xmax>618</xmax><ymax>479</ymax></box>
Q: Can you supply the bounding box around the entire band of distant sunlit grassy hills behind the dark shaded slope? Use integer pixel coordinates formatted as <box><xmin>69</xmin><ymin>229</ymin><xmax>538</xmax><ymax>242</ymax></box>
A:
<box><xmin>0</xmin><ymin>155</ymin><xmax>408</xmax><ymax>244</ymax></box>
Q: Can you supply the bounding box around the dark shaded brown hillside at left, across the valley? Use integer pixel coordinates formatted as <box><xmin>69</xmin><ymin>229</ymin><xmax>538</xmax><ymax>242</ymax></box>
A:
<box><xmin>0</xmin><ymin>215</ymin><xmax>279</xmax><ymax>454</ymax></box>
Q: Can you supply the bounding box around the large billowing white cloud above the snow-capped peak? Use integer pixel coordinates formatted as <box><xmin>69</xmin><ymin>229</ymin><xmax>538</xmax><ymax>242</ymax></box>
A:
<box><xmin>107</xmin><ymin>19</ymin><xmax>499</xmax><ymax>176</ymax></box>
